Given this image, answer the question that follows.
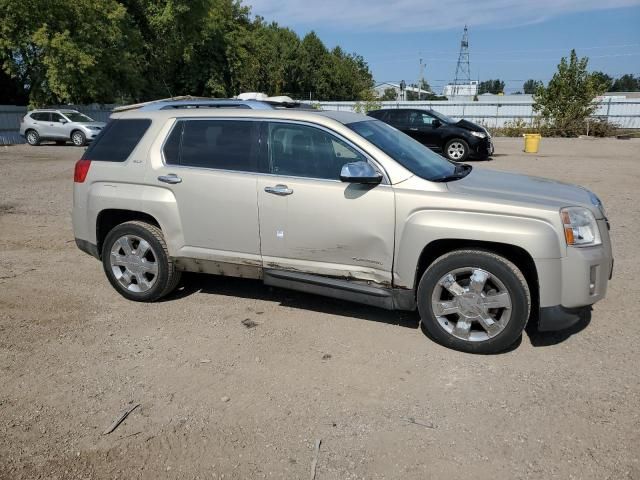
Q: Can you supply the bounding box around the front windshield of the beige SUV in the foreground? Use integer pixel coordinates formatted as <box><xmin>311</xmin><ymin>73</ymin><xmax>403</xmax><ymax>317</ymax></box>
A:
<box><xmin>347</xmin><ymin>120</ymin><xmax>456</xmax><ymax>180</ymax></box>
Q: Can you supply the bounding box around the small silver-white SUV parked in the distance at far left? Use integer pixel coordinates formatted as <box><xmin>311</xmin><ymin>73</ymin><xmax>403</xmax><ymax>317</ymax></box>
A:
<box><xmin>20</xmin><ymin>109</ymin><xmax>106</xmax><ymax>147</ymax></box>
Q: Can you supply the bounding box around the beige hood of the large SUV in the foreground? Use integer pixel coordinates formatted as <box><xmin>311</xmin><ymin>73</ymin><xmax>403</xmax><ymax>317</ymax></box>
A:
<box><xmin>447</xmin><ymin>168</ymin><xmax>603</xmax><ymax>218</ymax></box>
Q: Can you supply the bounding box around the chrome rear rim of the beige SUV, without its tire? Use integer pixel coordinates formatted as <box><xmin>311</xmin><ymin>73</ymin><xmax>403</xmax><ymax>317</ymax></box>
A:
<box><xmin>109</xmin><ymin>235</ymin><xmax>158</xmax><ymax>293</ymax></box>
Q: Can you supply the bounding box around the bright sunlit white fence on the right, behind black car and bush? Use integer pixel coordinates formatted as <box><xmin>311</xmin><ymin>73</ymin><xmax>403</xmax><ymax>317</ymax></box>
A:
<box><xmin>307</xmin><ymin>99</ymin><xmax>640</xmax><ymax>128</ymax></box>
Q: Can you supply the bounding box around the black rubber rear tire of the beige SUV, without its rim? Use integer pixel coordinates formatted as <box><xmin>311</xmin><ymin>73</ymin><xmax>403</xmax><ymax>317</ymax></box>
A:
<box><xmin>102</xmin><ymin>220</ymin><xmax>182</xmax><ymax>302</ymax></box>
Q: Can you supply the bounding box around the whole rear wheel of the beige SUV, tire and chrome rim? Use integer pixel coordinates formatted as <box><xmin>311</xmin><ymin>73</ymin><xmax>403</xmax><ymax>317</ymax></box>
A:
<box><xmin>102</xmin><ymin>221</ymin><xmax>181</xmax><ymax>302</ymax></box>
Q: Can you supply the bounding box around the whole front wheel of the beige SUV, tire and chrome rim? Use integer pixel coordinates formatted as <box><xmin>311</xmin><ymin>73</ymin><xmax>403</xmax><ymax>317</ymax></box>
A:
<box><xmin>417</xmin><ymin>250</ymin><xmax>531</xmax><ymax>353</ymax></box>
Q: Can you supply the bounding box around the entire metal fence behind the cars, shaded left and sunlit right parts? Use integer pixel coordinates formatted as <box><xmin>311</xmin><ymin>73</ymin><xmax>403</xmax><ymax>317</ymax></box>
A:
<box><xmin>0</xmin><ymin>98</ymin><xmax>640</xmax><ymax>145</ymax></box>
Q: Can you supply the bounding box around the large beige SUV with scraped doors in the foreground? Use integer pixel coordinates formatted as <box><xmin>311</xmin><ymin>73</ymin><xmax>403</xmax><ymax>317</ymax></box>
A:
<box><xmin>73</xmin><ymin>101</ymin><xmax>613</xmax><ymax>353</ymax></box>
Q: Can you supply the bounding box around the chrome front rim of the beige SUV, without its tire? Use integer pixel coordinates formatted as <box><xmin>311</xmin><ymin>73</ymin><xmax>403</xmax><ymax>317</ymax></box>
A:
<box><xmin>431</xmin><ymin>267</ymin><xmax>511</xmax><ymax>342</ymax></box>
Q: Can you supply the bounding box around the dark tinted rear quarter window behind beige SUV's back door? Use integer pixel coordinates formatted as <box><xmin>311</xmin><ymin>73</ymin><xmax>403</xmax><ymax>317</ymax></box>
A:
<box><xmin>82</xmin><ymin>118</ymin><xmax>151</xmax><ymax>162</ymax></box>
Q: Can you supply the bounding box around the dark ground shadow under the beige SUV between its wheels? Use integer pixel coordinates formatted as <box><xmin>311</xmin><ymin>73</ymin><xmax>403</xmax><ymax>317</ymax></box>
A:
<box><xmin>160</xmin><ymin>273</ymin><xmax>420</xmax><ymax>329</ymax></box>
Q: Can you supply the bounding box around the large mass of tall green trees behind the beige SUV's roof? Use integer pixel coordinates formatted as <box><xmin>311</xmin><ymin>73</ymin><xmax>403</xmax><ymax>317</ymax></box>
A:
<box><xmin>0</xmin><ymin>0</ymin><xmax>373</xmax><ymax>105</ymax></box>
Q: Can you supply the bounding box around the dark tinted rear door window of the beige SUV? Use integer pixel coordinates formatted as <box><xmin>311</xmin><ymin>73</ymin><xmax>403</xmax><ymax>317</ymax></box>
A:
<box><xmin>163</xmin><ymin>119</ymin><xmax>260</xmax><ymax>172</ymax></box>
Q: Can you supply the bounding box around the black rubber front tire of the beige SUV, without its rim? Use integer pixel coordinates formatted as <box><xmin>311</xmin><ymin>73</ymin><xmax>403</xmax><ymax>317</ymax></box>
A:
<box><xmin>417</xmin><ymin>250</ymin><xmax>531</xmax><ymax>354</ymax></box>
